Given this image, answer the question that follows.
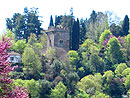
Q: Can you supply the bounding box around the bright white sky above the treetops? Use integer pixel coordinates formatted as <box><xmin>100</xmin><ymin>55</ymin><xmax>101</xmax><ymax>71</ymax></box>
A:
<box><xmin>0</xmin><ymin>0</ymin><xmax>130</xmax><ymax>34</ymax></box>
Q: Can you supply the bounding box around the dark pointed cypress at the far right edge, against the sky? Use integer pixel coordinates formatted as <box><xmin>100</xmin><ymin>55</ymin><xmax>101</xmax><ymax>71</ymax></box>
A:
<box><xmin>121</xmin><ymin>15</ymin><xmax>129</xmax><ymax>36</ymax></box>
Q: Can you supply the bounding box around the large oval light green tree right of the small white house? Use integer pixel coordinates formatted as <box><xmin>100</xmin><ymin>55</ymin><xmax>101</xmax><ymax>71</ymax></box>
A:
<box><xmin>22</xmin><ymin>47</ymin><xmax>42</xmax><ymax>79</ymax></box>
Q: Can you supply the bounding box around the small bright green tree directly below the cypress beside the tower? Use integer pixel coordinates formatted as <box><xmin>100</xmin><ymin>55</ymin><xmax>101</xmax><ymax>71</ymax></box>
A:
<box><xmin>68</xmin><ymin>50</ymin><xmax>79</xmax><ymax>69</ymax></box>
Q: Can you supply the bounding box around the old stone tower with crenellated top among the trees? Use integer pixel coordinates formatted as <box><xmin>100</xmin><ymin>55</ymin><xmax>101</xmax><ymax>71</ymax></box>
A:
<box><xmin>46</xmin><ymin>26</ymin><xmax>69</xmax><ymax>51</ymax></box>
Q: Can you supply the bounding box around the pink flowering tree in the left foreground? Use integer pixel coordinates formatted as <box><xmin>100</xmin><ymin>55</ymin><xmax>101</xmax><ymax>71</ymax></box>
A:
<box><xmin>0</xmin><ymin>37</ymin><xmax>29</xmax><ymax>98</ymax></box>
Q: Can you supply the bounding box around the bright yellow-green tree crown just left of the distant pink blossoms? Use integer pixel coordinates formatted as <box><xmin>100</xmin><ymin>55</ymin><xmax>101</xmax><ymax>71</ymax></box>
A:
<box><xmin>99</xmin><ymin>30</ymin><xmax>112</xmax><ymax>46</ymax></box>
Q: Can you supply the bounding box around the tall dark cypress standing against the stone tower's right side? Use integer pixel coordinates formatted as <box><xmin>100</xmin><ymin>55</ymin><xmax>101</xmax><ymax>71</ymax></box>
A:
<box><xmin>72</xmin><ymin>19</ymin><xmax>80</xmax><ymax>50</ymax></box>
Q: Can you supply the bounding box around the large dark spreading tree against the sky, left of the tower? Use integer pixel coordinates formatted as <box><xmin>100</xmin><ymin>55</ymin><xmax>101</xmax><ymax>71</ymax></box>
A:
<box><xmin>6</xmin><ymin>8</ymin><xmax>42</xmax><ymax>40</ymax></box>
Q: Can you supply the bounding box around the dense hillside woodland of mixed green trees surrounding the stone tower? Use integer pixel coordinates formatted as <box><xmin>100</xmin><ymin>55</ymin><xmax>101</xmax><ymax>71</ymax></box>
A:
<box><xmin>0</xmin><ymin>9</ymin><xmax>130</xmax><ymax>98</ymax></box>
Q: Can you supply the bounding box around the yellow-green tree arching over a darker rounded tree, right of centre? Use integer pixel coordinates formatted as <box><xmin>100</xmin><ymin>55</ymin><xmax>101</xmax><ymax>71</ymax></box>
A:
<box><xmin>79</xmin><ymin>39</ymin><xmax>99</xmax><ymax>74</ymax></box>
